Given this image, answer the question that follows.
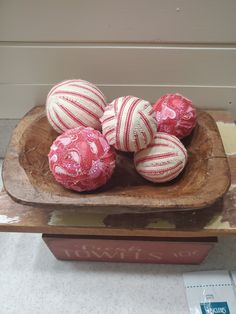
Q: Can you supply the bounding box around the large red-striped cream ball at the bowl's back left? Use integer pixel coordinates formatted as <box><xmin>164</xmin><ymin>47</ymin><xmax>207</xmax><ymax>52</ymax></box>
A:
<box><xmin>46</xmin><ymin>80</ymin><xmax>106</xmax><ymax>133</ymax></box>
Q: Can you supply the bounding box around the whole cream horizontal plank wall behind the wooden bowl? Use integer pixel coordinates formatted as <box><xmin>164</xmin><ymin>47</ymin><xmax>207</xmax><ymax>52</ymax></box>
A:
<box><xmin>0</xmin><ymin>0</ymin><xmax>236</xmax><ymax>119</ymax></box>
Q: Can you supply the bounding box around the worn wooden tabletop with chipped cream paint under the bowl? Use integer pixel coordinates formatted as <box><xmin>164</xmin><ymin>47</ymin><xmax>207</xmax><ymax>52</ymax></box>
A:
<box><xmin>0</xmin><ymin>111</ymin><xmax>236</xmax><ymax>238</ymax></box>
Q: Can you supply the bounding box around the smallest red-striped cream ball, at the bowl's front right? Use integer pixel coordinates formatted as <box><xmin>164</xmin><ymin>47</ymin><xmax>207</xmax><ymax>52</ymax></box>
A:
<box><xmin>134</xmin><ymin>132</ymin><xmax>187</xmax><ymax>183</ymax></box>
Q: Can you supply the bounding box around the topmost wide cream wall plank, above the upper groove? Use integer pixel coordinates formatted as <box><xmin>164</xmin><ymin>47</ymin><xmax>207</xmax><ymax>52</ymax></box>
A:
<box><xmin>0</xmin><ymin>0</ymin><xmax>236</xmax><ymax>43</ymax></box>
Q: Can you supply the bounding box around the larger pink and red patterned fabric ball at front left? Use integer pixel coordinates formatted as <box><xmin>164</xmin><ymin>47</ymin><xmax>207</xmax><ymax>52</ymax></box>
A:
<box><xmin>48</xmin><ymin>127</ymin><xmax>115</xmax><ymax>192</ymax></box>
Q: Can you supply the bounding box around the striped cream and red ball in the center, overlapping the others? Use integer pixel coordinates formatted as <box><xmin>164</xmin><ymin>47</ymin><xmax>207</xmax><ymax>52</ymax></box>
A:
<box><xmin>101</xmin><ymin>96</ymin><xmax>157</xmax><ymax>152</ymax></box>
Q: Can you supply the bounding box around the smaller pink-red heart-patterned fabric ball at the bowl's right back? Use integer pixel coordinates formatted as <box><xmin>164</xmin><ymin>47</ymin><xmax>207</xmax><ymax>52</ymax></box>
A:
<box><xmin>153</xmin><ymin>94</ymin><xmax>197</xmax><ymax>138</ymax></box>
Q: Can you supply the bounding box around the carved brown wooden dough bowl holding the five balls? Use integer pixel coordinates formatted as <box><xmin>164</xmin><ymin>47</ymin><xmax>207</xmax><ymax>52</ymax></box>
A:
<box><xmin>3</xmin><ymin>106</ymin><xmax>230</xmax><ymax>214</ymax></box>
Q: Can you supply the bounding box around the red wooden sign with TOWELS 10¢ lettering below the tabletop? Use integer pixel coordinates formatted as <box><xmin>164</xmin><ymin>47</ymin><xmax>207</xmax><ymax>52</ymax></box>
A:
<box><xmin>43</xmin><ymin>234</ymin><xmax>217</xmax><ymax>264</ymax></box>
